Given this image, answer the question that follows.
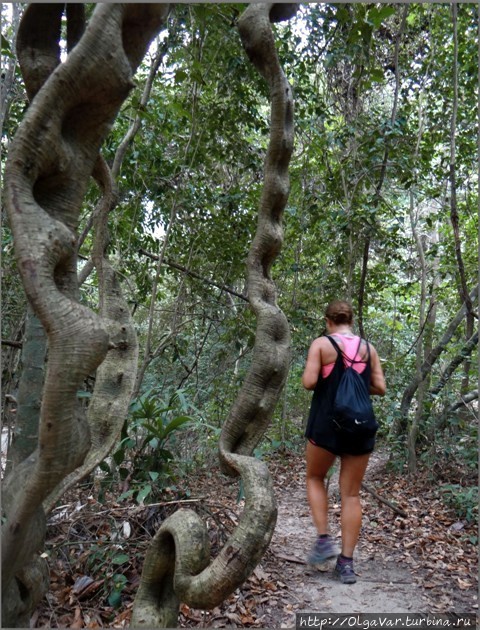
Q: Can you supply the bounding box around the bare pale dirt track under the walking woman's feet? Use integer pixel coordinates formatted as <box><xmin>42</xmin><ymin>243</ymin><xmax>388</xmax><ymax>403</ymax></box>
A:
<box><xmin>258</xmin><ymin>454</ymin><xmax>432</xmax><ymax>628</ymax></box>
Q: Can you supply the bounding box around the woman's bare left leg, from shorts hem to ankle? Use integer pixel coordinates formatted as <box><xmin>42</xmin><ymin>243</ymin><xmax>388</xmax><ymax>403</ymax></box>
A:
<box><xmin>306</xmin><ymin>442</ymin><xmax>335</xmax><ymax>535</ymax></box>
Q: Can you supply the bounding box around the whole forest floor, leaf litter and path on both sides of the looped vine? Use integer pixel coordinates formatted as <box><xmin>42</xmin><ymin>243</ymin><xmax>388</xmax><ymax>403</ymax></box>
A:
<box><xmin>35</xmin><ymin>449</ymin><xmax>478</xmax><ymax>628</ymax></box>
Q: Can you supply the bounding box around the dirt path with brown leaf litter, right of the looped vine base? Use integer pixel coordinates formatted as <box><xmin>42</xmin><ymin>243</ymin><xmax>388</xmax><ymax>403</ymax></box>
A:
<box><xmin>176</xmin><ymin>447</ymin><xmax>478</xmax><ymax>628</ymax></box>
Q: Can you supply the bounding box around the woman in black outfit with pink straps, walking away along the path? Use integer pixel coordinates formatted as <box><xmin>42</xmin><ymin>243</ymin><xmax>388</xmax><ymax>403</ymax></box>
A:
<box><xmin>302</xmin><ymin>300</ymin><xmax>385</xmax><ymax>584</ymax></box>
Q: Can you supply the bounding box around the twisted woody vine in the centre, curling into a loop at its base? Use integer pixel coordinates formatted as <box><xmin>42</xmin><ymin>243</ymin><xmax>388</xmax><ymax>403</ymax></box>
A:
<box><xmin>131</xmin><ymin>4</ymin><xmax>296</xmax><ymax>627</ymax></box>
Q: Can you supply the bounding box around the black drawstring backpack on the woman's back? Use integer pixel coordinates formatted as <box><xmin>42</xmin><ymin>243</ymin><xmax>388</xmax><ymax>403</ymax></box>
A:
<box><xmin>327</xmin><ymin>335</ymin><xmax>378</xmax><ymax>437</ymax></box>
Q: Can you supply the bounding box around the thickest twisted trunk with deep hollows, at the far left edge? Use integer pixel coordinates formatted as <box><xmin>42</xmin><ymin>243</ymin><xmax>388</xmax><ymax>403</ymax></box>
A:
<box><xmin>2</xmin><ymin>4</ymin><xmax>168</xmax><ymax>626</ymax></box>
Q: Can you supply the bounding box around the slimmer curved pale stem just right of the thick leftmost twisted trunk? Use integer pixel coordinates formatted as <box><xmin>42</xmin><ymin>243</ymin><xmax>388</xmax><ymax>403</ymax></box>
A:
<box><xmin>43</xmin><ymin>47</ymin><xmax>171</xmax><ymax>513</ymax></box>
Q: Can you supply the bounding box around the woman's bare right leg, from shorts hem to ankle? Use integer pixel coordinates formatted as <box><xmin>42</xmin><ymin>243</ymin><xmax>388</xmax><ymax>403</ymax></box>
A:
<box><xmin>339</xmin><ymin>453</ymin><xmax>370</xmax><ymax>558</ymax></box>
